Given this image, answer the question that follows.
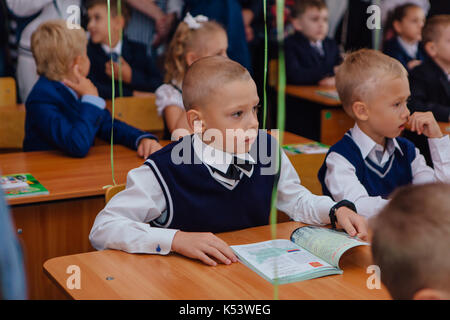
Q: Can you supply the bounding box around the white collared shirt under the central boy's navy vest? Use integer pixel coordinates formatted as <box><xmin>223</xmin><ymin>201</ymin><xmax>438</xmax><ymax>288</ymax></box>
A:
<box><xmin>89</xmin><ymin>138</ymin><xmax>335</xmax><ymax>254</ymax></box>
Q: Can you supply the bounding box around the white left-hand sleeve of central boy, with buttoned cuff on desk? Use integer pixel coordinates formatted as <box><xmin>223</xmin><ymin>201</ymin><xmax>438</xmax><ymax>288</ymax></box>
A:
<box><xmin>89</xmin><ymin>165</ymin><xmax>178</xmax><ymax>254</ymax></box>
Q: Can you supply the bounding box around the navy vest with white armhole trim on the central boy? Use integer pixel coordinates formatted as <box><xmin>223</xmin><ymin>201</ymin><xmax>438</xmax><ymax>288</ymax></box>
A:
<box><xmin>145</xmin><ymin>133</ymin><xmax>279</xmax><ymax>233</ymax></box>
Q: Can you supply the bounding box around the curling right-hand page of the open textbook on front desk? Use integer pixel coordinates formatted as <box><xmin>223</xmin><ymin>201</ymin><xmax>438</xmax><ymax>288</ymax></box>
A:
<box><xmin>291</xmin><ymin>226</ymin><xmax>370</xmax><ymax>268</ymax></box>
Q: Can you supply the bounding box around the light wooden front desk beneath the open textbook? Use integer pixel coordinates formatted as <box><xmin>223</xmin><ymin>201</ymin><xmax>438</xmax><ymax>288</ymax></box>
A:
<box><xmin>44</xmin><ymin>222</ymin><xmax>389</xmax><ymax>300</ymax></box>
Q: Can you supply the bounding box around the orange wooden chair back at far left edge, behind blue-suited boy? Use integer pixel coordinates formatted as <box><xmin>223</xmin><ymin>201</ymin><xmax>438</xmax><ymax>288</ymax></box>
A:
<box><xmin>0</xmin><ymin>101</ymin><xmax>25</xmax><ymax>153</ymax></box>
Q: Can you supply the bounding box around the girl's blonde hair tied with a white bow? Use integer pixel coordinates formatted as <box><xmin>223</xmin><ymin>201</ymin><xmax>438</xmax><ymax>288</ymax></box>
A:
<box><xmin>164</xmin><ymin>21</ymin><xmax>226</xmax><ymax>82</ymax></box>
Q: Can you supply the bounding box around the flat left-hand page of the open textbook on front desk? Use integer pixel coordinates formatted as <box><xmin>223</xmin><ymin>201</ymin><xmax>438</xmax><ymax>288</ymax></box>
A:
<box><xmin>231</xmin><ymin>239</ymin><xmax>342</xmax><ymax>284</ymax></box>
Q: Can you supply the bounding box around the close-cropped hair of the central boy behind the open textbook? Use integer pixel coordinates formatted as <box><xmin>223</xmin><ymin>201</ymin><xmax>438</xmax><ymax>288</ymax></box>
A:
<box><xmin>182</xmin><ymin>56</ymin><xmax>252</xmax><ymax>110</ymax></box>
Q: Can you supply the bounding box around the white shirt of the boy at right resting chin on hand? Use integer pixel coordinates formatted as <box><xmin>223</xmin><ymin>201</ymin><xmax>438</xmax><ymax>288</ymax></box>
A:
<box><xmin>325</xmin><ymin>124</ymin><xmax>450</xmax><ymax>217</ymax></box>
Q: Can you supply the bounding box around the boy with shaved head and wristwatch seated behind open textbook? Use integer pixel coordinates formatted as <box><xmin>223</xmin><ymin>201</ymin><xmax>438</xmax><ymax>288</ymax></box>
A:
<box><xmin>90</xmin><ymin>56</ymin><xmax>367</xmax><ymax>266</ymax></box>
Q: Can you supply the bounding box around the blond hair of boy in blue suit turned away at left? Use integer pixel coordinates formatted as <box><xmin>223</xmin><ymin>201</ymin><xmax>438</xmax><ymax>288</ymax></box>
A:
<box><xmin>31</xmin><ymin>20</ymin><xmax>87</xmax><ymax>81</ymax></box>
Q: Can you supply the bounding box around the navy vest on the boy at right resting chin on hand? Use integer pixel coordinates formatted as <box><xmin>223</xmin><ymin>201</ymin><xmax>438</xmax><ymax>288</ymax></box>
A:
<box><xmin>318</xmin><ymin>131</ymin><xmax>416</xmax><ymax>199</ymax></box>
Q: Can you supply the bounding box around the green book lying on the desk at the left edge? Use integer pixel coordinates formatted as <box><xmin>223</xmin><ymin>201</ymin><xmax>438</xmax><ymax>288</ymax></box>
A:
<box><xmin>0</xmin><ymin>173</ymin><xmax>49</xmax><ymax>199</ymax></box>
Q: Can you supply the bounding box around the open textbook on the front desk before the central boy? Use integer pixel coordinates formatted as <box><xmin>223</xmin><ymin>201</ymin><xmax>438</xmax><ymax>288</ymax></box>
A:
<box><xmin>231</xmin><ymin>226</ymin><xmax>369</xmax><ymax>284</ymax></box>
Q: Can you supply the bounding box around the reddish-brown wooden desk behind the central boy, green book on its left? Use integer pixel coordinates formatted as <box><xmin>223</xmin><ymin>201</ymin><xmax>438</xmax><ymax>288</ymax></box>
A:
<box><xmin>0</xmin><ymin>132</ymin><xmax>324</xmax><ymax>299</ymax></box>
